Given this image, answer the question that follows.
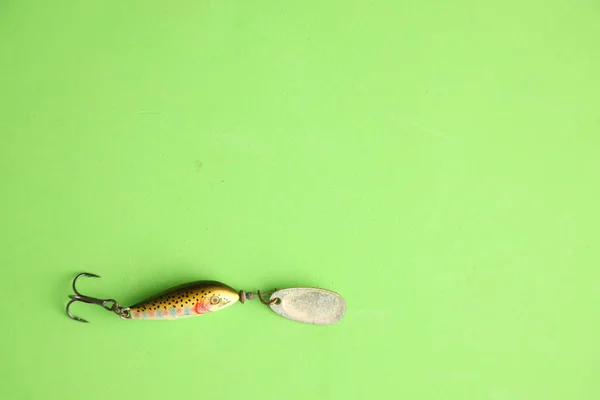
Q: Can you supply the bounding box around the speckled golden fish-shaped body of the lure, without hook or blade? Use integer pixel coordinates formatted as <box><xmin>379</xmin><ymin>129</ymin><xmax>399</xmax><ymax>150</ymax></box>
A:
<box><xmin>129</xmin><ymin>281</ymin><xmax>240</xmax><ymax>320</ymax></box>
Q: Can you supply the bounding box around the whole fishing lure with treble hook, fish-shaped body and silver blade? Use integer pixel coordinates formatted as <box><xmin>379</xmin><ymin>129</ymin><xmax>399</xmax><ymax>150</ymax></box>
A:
<box><xmin>67</xmin><ymin>272</ymin><xmax>346</xmax><ymax>325</ymax></box>
